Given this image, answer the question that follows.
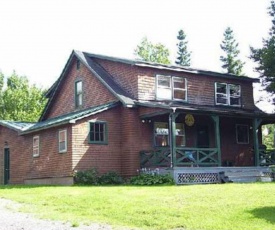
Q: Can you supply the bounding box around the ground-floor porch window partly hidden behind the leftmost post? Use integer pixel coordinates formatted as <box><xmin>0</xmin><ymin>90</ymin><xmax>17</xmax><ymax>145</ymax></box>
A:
<box><xmin>154</xmin><ymin>122</ymin><xmax>185</xmax><ymax>147</ymax></box>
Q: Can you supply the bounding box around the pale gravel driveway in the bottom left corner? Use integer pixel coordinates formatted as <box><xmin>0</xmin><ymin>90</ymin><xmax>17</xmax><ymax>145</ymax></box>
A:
<box><xmin>0</xmin><ymin>198</ymin><xmax>112</xmax><ymax>230</ymax></box>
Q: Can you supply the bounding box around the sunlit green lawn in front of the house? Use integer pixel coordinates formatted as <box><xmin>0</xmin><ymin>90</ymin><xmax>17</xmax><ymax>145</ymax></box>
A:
<box><xmin>0</xmin><ymin>183</ymin><xmax>275</xmax><ymax>230</ymax></box>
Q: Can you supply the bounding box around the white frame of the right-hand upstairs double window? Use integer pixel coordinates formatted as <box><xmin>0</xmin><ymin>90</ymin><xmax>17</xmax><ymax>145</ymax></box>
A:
<box><xmin>215</xmin><ymin>82</ymin><xmax>241</xmax><ymax>107</ymax></box>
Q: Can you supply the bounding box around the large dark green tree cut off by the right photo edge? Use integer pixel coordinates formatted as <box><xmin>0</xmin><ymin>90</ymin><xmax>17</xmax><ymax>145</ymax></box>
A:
<box><xmin>250</xmin><ymin>1</ymin><xmax>275</xmax><ymax>97</ymax></box>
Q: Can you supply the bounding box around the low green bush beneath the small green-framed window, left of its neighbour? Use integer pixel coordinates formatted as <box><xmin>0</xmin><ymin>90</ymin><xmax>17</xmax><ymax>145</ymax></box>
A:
<box><xmin>74</xmin><ymin>168</ymin><xmax>99</xmax><ymax>185</ymax></box>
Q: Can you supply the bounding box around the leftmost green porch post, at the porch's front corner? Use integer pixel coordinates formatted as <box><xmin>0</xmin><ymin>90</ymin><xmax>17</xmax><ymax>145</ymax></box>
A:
<box><xmin>169</xmin><ymin>112</ymin><xmax>179</xmax><ymax>168</ymax></box>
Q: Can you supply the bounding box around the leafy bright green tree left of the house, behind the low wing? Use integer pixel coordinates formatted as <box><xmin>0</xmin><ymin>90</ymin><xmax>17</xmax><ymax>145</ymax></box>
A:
<box><xmin>0</xmin><ymin>72</ymin><xmax>46</xmax><ymax>122</ymax></box>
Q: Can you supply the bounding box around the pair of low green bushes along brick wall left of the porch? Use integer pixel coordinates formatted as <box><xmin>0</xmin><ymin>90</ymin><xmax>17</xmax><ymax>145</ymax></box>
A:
<box><xmin>74</xmin><ymin>168</ymin><xmax>123</xmax><ymax>185</ymax></box>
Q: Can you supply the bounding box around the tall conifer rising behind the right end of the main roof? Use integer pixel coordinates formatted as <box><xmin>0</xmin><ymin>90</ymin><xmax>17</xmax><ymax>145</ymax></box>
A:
<box><xmin>220</xmin><ymin>27</ymin><xmax>244</xmax><ymax>75</ymax></box>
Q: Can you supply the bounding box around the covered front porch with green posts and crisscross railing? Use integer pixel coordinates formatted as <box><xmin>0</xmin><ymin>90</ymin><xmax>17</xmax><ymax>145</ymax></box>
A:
<box><xmin>140</xmin><ymin>108</ymin><xmax>275</xmax><ymax>169</ymax></box>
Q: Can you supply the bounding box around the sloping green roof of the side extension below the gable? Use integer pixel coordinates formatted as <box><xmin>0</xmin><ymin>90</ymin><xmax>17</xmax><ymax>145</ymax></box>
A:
<box><xmin>21</xmin><ymin>101</ymin><xmax>120</xmax><ymax>135</ymax></box>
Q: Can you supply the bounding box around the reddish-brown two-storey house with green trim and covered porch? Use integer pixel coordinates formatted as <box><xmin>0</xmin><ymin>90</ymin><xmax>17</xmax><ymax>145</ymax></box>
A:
<box><xmin>0</xmin><ymin>51</ymin><xmax>275</xmax><ymax>184</ymax></box>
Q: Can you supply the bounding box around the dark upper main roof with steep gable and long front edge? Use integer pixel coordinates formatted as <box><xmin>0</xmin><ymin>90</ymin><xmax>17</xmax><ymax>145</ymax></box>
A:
<box><xmin>39</xmin><ymin>50</ymin><xmax>259</xmax><ymax>121</ymax></box>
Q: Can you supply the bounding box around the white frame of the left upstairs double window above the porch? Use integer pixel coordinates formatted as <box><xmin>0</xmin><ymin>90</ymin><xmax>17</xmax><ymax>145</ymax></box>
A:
<box><xmin>156</xmin><ymin>75</ymin><xmax>187</xmax><ymax>101</ymax></box>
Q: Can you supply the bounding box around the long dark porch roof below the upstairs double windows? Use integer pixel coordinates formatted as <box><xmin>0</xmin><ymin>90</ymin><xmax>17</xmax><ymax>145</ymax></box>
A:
<box><xmin>136</xmin><ymin>101</ymin><xmax>275</xmax><ymax>119</ymax></box>
